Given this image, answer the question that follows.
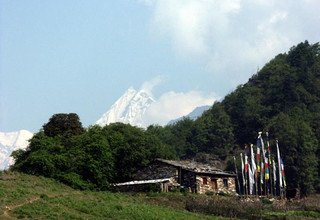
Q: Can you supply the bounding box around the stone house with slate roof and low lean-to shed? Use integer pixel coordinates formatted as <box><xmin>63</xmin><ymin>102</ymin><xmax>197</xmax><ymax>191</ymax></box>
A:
<box><xmin>115</xmin><ymin>159</ymin><xmax>236</xmax><ymax>194</ymax></box>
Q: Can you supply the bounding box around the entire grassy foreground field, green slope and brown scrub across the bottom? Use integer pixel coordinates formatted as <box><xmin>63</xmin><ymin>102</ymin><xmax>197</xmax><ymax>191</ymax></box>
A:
<box><xmin>0</xmin><ymin>172</ymin><xmax>320</xmax><ymax>220</ymax></box>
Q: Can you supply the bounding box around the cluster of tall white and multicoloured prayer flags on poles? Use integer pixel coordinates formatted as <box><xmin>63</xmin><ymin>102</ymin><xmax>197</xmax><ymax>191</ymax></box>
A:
<box><xmin>234</xmin><ymin>132</ymin><xmax>287</xmax><ymax>197</ymax></box>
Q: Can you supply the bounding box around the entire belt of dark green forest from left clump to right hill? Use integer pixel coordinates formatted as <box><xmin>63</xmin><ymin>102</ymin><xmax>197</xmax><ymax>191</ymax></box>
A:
<box><xmin>12</xmin><ymin>41</ymin><xmax>320</xmax><ymax>195</ymax></box>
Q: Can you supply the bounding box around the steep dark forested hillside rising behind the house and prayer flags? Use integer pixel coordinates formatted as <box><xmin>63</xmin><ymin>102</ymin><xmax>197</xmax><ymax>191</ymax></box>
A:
<box><xmin>153</xmin><ymin>41</ymin><xmax>320</xmax><ymax>195</ymax></box>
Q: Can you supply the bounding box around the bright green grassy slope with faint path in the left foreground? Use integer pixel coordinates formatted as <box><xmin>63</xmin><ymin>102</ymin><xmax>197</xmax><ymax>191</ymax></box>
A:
<box><xmin>0</xmin><ymin>172</ymin><xmax>217</xmax><ymax>220</ymax></box>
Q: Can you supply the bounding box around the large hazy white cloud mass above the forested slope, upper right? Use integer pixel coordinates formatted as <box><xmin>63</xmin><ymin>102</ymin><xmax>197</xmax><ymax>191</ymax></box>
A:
<box><xmin>144</xmin><ymin>0</ymin><xmax>320</xmax><ymax>87</ymax></box>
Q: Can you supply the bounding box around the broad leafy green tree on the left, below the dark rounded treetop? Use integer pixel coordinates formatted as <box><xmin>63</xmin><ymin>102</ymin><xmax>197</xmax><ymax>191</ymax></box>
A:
<box><xmin>12</xmin><ymin>117</ymin><xmax>115</xmax><ymax>190</ymax></box>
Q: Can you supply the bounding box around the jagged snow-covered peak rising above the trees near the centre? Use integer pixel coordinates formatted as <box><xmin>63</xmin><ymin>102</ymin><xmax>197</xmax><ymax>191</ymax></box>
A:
<box><xmin>96</xmin><ymin>87</ymin><xmax>155</xmax><ymax>127</ymax></box>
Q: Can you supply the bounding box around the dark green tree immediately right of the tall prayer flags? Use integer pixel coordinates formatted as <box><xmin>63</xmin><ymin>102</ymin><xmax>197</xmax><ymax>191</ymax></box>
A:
<box><xmin>268</xmin><ymin>111</ymin><xmax>318</xmax><ymax>196</ymax></box>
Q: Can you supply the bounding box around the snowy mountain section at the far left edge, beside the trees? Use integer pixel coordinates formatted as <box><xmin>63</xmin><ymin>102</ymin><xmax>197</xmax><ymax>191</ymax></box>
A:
<box><xmin>0</xmin><ymin>130</ymin><xmax>33</xmax><ymax>170</ymax></box>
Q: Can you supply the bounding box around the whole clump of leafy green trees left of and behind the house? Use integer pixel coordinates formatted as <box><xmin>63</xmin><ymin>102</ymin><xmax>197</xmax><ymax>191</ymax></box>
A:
<box><xmin>11</xmin><ymin>114</ymin><xmax>175</xmax><ymax>190</ymax></box>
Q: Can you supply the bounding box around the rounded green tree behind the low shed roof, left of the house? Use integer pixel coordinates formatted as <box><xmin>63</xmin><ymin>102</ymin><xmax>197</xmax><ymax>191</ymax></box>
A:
<box><xmin>103</xmin><ymin>123</ymin><xmax>173</xmax><ymax>182</ymax></box>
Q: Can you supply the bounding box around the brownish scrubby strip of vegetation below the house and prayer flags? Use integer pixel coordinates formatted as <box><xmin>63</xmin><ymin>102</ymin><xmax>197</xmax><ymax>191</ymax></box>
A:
<box><xmin>186</xmin><ymin>195</ymin><xmax>320</xmax><ymax>219</ymax></box>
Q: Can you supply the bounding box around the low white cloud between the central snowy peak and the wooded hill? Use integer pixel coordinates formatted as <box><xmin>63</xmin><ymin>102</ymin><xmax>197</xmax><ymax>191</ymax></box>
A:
<box><xmin>144</xmin><ymin>91</ymin><xmax>216</xmax><ymax>125</ymax></box>
